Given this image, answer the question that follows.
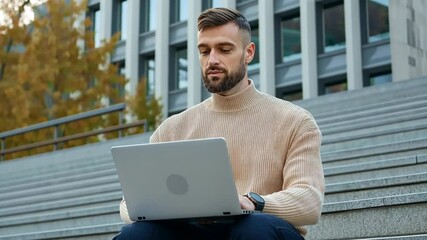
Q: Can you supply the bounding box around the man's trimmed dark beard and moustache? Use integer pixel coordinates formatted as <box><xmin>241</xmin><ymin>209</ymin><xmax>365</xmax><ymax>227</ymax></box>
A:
<box><xmin>203</xmin><ymin>56</ymin><xmax>246</xmax><ymax>93</ymax></box>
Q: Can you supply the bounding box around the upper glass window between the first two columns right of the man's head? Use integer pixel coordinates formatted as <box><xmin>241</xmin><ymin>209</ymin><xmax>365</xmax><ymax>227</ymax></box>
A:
<box><xmin>280</xmin><ymin>16</ymin><xmax>301</xmax><ymax>62</ymax></box>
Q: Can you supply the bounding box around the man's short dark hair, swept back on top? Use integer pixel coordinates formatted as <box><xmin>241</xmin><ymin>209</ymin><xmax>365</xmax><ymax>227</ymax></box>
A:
<box><xmin>197</xmin><ymin>8</ymin><xmax>251</xmax><ymax>37</ymax></box>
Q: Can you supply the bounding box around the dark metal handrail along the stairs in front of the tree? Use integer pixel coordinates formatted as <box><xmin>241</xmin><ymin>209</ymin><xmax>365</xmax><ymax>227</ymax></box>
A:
<box><xmin>0</xmin><ymin>103</ymin><xmax>147</xmax><ymax>161</ymax></box>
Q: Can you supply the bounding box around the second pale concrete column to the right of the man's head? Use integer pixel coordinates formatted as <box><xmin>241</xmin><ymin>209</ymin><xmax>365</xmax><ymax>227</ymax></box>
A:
<box><xmin>300</xmin><ymin>0</ymin><xmax>318</xmax><ymax>99</ymax></box>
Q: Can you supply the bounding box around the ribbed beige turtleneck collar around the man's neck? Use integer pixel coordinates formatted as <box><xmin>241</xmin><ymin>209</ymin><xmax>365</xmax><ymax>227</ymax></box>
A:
<box><xmin>206</xmin><ymin>79</ymin><xmax>261</xmax><ymax>112</ymax></box>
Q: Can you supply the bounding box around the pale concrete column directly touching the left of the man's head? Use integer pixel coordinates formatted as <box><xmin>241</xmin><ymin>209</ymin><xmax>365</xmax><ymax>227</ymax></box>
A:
<box><xmin>187</xmin><ymin>0</ymin><xmax>202</xmax><ymax>107</ymax></box>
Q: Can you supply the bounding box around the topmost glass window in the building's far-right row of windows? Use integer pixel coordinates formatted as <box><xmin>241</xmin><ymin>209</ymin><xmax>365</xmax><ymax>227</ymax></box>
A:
<box><xmin>367</xmin><ymin>0</ymin><xmax>390</xmax><ymax>43</ymax></box>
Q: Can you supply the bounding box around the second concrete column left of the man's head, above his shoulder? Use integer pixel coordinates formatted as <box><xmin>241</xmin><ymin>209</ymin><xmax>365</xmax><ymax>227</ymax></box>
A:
<box><xmin>154</xmin><ymin>0</ymin><xmax>170</xmax><ymax>118</ymax></box>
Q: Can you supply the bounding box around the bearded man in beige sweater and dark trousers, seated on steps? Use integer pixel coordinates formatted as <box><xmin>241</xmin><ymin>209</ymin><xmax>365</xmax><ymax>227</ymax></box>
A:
<box><xmin>116</xmin><ymin>8</ymin><xmax>324</xmax><ymax>239</ymax></box>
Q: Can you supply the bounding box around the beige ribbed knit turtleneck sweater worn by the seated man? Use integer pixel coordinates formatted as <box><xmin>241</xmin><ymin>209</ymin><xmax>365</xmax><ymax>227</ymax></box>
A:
<box><xmin>120</xmin><ymin>81</ymin><xmax>324</xmax><ymax>235</ymax></box>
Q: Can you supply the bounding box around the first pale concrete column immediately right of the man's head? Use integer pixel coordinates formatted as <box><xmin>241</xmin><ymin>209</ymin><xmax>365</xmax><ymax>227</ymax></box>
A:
<box><xmin>255</xmin><ymin>1</ymin><xmax>276</xmax><ymax>96</ymax></box>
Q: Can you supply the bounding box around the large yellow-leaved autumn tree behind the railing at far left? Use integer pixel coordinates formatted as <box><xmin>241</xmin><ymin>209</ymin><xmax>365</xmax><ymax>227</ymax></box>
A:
<box><xmin>0</xmin><ymin>0</ymin><xmax>161</xmax><ymax>160</ymax></box>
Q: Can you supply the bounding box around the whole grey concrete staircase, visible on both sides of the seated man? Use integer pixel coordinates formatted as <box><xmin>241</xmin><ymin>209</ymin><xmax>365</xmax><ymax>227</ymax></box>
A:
<box><xmin>0</xmin><ymin>78</ymin><xmax>427</xmax><ymax>240</ymax></box>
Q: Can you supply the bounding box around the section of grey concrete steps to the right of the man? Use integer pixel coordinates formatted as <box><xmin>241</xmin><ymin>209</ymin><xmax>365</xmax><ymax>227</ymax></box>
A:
<box><xmin>297</xmin><ymin>78</ymin><xmax>427</xmax><ymax>239</ymax></box>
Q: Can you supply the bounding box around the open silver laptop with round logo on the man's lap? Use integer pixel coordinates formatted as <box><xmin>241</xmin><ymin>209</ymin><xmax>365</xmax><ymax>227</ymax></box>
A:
<box><xmin>111</xmin><ymin>138</ymin><xmax>251</xmax><ymax>221</ymax></box>
